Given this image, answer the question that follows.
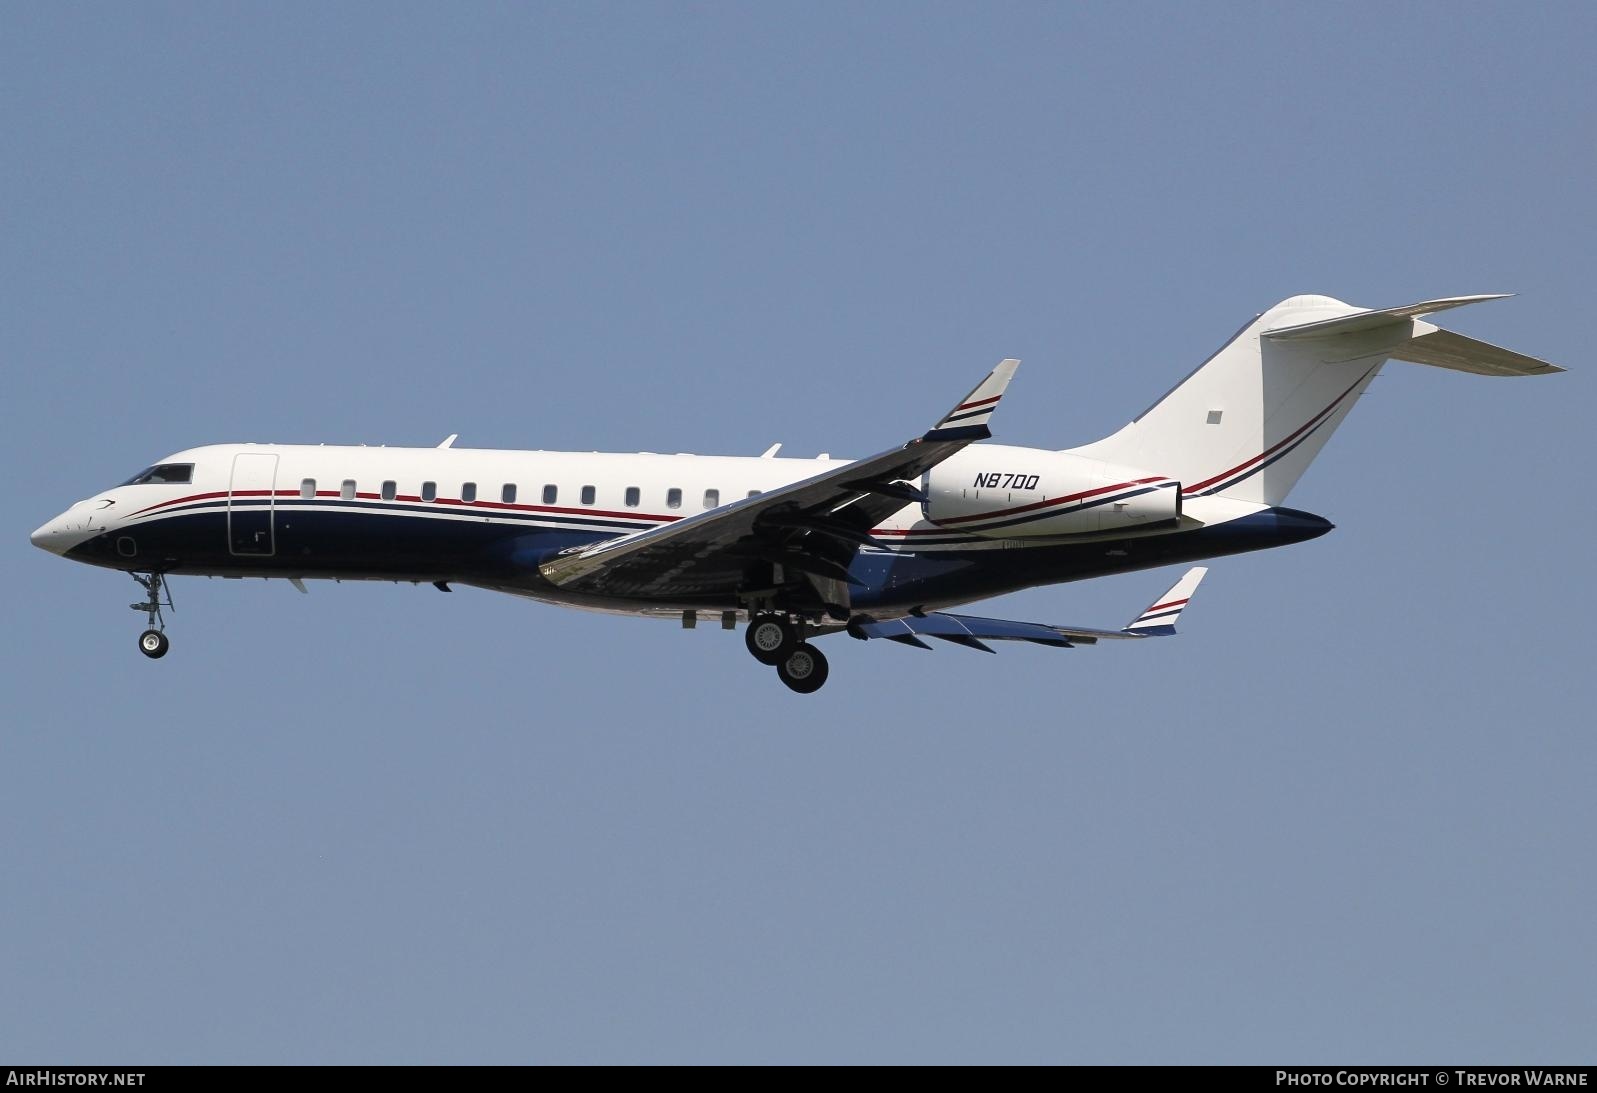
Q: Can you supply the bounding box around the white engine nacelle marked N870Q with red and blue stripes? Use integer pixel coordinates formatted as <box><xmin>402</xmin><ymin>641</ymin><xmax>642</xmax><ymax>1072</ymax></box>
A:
<box><xmin>925</xmin><ymin>444</ymin><xmax>1182</xmax><ymax>539</ymax></box>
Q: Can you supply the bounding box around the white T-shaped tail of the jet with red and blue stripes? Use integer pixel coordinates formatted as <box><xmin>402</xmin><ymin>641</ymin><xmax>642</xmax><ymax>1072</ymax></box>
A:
<box><xmin>1073</xmin><ymin>296</ymin><xmax>1563</xmax><ymax>505</ymax></box>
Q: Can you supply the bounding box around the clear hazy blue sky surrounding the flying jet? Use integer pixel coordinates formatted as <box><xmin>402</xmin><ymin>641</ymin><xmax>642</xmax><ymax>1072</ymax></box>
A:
<box><xmin>0</xmin><ymin>3</ymin><xmax>1597</xmax><ymax>1063</ymax></box>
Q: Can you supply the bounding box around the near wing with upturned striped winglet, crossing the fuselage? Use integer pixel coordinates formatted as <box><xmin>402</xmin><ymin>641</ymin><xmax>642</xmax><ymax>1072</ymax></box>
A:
<box><xmin>538</xmin><ymin>360</ymin><xmax>1020</xmax><ymax>601</ymax></box>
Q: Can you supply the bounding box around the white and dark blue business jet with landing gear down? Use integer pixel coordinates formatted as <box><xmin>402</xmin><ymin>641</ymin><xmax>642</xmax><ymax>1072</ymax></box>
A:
<box><xmin>32</xmin><ymin>296</ymin><xmax>1563</xmax><ymax>694</ymax></box>
